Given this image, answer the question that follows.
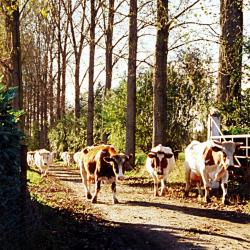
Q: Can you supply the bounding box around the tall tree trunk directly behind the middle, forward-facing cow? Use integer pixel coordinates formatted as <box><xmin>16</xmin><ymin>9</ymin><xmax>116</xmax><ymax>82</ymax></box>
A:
<box><xmin>153</xmin><ymin>0</ymin><xmax>169</xmax><ymax>146</ymax></box>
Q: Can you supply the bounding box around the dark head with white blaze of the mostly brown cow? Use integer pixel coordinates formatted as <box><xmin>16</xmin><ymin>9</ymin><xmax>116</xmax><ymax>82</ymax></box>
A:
<box><xmin>103</xmin><ymin>154</ymin><xmax>132</xmax><ymax>180</ymax></box>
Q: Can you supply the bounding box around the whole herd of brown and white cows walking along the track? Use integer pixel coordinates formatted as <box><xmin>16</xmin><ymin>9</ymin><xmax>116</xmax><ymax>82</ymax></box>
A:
<box><xmin>27</xmin><ymin>141</ymin><xmax>240</xmax><ymax>204</ymax></box>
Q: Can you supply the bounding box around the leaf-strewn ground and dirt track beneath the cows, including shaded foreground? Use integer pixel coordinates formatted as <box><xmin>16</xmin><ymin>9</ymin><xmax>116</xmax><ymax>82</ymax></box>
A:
<box><xmin>26</xmin><ymin>165</ymin><xmax>250</xmax><ymax>250</ymax></box>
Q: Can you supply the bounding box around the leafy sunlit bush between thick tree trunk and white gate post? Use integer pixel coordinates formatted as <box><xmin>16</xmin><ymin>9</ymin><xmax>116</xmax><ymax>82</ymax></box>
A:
<box><xmin>166</xmin><ymin>49</ymin><xmax>213</xmax><ymax>149</ymax></box>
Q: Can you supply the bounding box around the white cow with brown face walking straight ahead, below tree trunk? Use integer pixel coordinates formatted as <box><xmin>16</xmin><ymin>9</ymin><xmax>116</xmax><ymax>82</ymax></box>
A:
<box><xmin>145</xmin><ymin>144</ymin><xmax>175</xmax><ymax>196</ymax></box>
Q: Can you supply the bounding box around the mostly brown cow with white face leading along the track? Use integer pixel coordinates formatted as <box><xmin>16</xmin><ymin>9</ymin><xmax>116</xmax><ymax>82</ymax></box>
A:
<box><xmin>78</xmin><ymin>144</ymin><xmax>132</xmax><ymax>204</ymax></box>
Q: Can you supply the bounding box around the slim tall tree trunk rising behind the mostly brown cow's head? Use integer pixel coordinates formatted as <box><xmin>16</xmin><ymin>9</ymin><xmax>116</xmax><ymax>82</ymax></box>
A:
<box><xmin>126</xmin><ymin>0</ymin><xmax>138</xmax><ymax>163</ymax></box>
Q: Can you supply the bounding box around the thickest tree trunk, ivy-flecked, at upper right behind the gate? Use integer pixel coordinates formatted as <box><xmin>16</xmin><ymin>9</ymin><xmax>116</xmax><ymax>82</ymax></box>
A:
<box><xmin>218</xmin><ymin>0</ymin><xmax>243</xmax><ymax>103</ymax></box>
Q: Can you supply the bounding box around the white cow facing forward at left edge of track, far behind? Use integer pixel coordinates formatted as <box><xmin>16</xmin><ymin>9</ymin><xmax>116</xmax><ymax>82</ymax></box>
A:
<box><xmin>34</xmin><ymin>149</ymin><xmax>53</xmax><ymax>176</ymax></box>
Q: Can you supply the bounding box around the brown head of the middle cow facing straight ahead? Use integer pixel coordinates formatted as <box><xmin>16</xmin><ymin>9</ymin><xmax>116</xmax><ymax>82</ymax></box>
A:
<box><xmin>148</xmin><ymin>151</ymin><xmax>173</xmax><ymax>178</ymax></box>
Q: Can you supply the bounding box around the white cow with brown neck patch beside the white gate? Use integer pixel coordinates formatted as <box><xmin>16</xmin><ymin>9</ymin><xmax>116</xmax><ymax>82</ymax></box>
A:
<box><xmin>184</xmin><ymin>140</ymin><xmax>240</xmax><ymax>204</ymax></box>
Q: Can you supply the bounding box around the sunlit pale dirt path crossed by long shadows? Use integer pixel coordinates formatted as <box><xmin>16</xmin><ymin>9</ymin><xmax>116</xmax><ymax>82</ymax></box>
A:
<box><xmin>50</xmin><ymin>166</ymin><xmax>250</xmax><ymax>250</ymax></box>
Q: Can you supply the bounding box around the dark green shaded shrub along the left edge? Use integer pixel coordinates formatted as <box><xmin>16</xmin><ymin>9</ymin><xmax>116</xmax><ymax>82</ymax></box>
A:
<box><xmin>0</xmin><ymin>81</ymin><xmax>23</xmax><ymax>246</ymax></box>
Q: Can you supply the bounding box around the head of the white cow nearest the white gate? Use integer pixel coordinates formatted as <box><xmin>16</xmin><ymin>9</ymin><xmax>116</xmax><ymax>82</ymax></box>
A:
<box><xmin>206</xmin><ymin>141</ymin><xmax>241</xmax><ymax>169</ymax></box>
